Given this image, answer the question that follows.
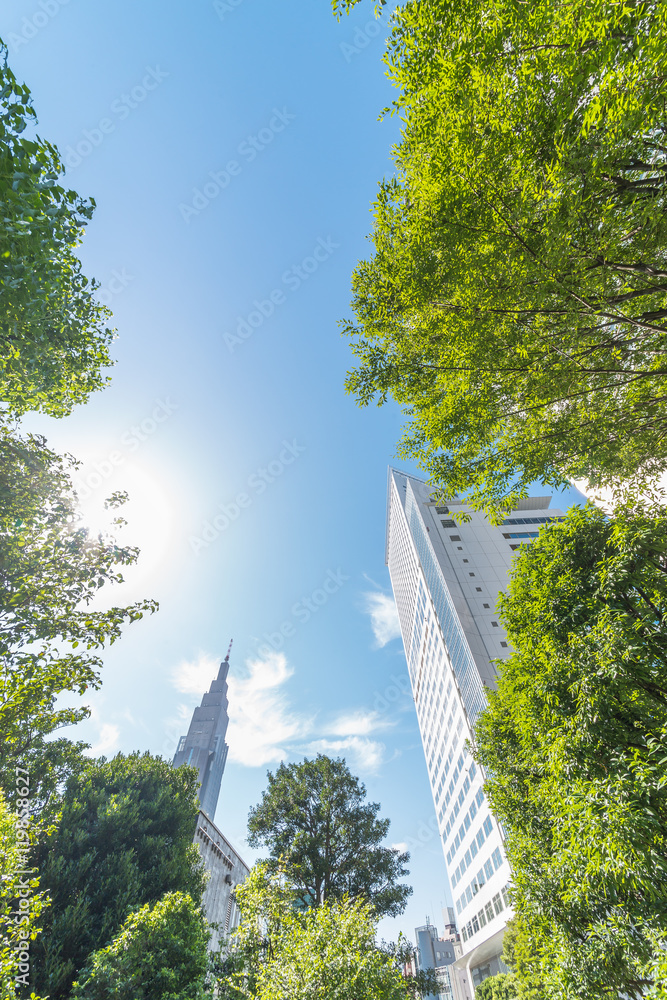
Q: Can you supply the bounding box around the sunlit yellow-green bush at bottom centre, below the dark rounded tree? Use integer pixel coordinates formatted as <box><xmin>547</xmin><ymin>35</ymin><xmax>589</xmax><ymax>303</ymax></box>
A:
<box><xmin>215</xmin><ymin>862</ymin><xmax>436</xmax><ymax>1000</ymax></box>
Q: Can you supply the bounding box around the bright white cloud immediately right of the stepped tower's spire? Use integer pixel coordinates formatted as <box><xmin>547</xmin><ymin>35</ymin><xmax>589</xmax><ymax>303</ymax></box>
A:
<box><xmin>227</xmin><ymin>653</ymin><xmax>312</xmax><ymax>767</ymax></box>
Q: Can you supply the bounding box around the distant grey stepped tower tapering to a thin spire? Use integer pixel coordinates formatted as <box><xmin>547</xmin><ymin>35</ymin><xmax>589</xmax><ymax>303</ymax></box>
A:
<box><xmin>173</xmin><ymin>642</ymin><xmax>232</xmax><ymax>820</ymax></box>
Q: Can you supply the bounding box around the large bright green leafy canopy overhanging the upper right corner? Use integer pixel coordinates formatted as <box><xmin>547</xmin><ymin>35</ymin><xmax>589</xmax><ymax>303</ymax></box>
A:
<box><xmin>334</xmin><ymin>0</ymin><xmax>667</xmax><ymax>511</ymax></box>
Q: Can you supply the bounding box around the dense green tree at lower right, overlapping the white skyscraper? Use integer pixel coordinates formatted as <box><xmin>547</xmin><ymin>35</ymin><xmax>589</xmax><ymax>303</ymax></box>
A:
<box><xmin>476</xmin><ymin>507</ymin><xmax>667</xmax><ymax>1000</ymax></box>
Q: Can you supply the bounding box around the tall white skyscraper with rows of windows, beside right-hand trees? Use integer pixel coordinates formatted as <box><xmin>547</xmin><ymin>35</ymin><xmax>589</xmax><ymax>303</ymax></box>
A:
<box><xmin>386</xmin><ymin>469</ymin><xmax>562</xmax><ymax>989</ymax></box>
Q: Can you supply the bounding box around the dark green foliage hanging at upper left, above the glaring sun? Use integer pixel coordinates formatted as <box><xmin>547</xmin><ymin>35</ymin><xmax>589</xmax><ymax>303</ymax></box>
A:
<box><xmin>0</xmin><ymin>41</ymin><xmax>113</xmax><ymax>416</ymax></box>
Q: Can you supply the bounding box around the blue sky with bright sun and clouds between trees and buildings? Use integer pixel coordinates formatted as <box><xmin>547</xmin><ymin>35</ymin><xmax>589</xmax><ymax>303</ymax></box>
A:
<box><xmin>0</xmin><ymin>0</ymin><xmax>584</xmax><ymax>937</ymax></box>
